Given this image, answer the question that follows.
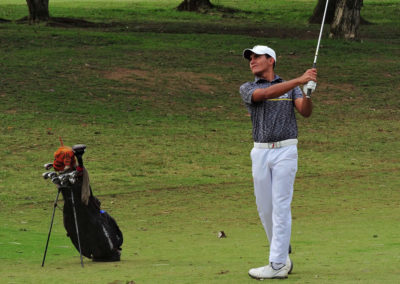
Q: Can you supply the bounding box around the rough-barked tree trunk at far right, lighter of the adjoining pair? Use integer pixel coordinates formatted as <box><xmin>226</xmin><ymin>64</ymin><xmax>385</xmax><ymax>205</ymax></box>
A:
<box><xmin>329</xmin><ymin>0</ymin><xmax>363</xmax><ymax>40</ymax></box>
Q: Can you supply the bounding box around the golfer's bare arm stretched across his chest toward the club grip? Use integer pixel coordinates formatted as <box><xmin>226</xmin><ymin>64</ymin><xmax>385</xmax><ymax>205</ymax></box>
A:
<box><xmin>252</xmin><ymin>68</ymin><xmax>317</xmax><ymax>102</ymax></box>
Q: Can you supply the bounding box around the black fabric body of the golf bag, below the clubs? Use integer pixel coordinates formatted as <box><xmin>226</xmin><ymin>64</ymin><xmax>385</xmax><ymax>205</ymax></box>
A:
<box><xmin>58</xmin><ymin>177</ymin><xmax>123</xmax><ymax>261</ymax></box>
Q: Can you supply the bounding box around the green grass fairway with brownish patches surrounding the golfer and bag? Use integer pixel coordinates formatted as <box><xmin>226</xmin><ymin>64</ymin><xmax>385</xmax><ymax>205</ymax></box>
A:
<box><xmin>0</xmin><ymin>0</ymin><xmax>400</xmax><ymax>283</ymax></box>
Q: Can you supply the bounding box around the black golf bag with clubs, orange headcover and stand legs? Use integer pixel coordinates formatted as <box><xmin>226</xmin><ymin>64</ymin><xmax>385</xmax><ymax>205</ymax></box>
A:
<box><xmin>42</xmin><ymin>144</ymin><xmax>123</xmax><ymax>267</ymax></box>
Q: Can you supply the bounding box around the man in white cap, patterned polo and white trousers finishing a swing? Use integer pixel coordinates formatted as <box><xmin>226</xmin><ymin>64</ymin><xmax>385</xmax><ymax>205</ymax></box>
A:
<box><xmin>240</xmin><ymin>45</ymin><xmax>317</xmax><ymax>279</ymax></box>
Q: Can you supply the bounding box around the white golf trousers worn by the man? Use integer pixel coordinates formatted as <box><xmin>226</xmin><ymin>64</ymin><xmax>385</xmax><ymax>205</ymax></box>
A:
<box><xmin>250</xmin><ymin>145</ymin><xmax>297</xmax><ymax>263</ymax></box>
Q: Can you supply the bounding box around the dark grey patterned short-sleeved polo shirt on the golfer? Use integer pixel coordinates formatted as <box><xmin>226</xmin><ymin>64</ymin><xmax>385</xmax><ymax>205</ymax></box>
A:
<box><xmin>240</xmin><ymin>75</ymin><xmax>303</xmax><ymax>143</ymax></box>
